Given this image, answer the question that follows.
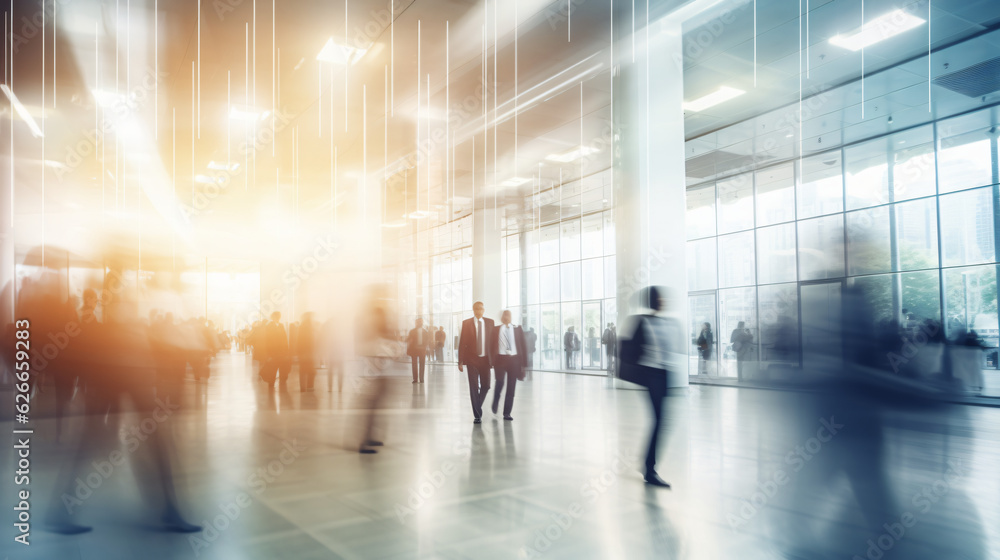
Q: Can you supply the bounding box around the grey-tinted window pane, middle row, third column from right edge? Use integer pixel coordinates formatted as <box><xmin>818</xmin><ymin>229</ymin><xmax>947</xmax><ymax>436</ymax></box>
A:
<box><xmin>847</xmin><ymin>206</ymin><xmax>892</xmax><ymax>276</ymax></box>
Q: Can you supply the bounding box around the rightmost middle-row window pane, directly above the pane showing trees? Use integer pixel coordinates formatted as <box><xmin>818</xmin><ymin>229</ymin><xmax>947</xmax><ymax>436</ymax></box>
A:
<box><xmin>940</xmin><ymin>188</ymin><xmax>994</xmax><ymax>266</ymax></box>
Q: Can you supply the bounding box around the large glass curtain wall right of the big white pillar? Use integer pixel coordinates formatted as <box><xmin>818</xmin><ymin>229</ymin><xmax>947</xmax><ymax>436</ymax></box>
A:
<box><xmin>687</xmin><ymin>108</ymin><xmax>1000</xmax><ymax>380</ymax></box>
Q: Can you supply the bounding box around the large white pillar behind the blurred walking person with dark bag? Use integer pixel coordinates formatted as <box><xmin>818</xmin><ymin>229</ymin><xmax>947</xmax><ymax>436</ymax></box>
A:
<box><xmin>612</xmin><ymin>2</ymin><xmax>690</xmax><ymax>387</ymax></box>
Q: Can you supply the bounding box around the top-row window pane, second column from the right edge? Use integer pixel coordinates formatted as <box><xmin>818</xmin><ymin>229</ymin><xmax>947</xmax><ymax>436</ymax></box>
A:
<box><xmin>890</xmin><ymin>125</ymin><xmax>937</xmax><ymax>200</ymax></box>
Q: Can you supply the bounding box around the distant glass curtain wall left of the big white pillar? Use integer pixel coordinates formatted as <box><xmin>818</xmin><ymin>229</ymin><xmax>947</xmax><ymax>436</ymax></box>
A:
<box><xmin>501</xmin><ymin>170</ymin><xmax>618</xmax><ymax>375</ymax></box>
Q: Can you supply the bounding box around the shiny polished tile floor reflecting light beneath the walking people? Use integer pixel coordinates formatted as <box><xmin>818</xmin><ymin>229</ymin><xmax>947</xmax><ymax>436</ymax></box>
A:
<box><xmin>0</xmin><ymin>352</ymin><xmax>1000</xmax><ymax>560</ymax></box>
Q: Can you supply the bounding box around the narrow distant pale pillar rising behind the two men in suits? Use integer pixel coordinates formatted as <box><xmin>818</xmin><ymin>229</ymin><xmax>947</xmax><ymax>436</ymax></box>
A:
<box><xmin>463</xmin><ymin>208</ymin><xmax>503</xmax><ymax>318</ymax></box>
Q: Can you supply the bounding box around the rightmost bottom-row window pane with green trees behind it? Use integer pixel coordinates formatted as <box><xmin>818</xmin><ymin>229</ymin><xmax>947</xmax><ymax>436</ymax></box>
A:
<box><xmin>944</xmin><ymin>266</ymin><xmax>998</xmax><ymax>368</ymax></box>
